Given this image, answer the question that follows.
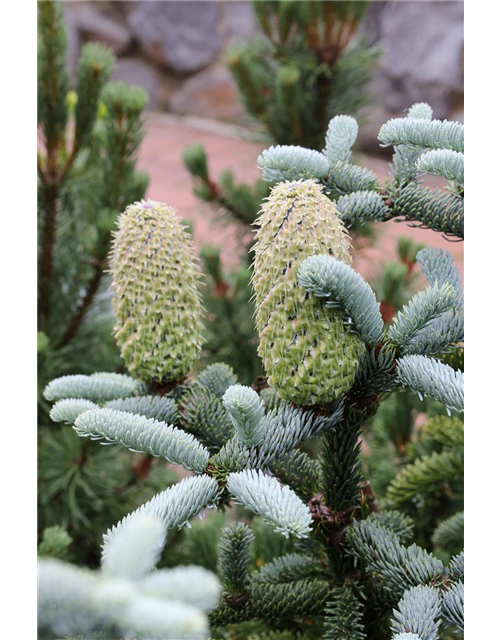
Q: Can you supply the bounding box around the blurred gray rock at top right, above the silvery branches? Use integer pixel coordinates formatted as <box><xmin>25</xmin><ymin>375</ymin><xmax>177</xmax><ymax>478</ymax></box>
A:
<box><xmin>380</xmin><ymin>0</ymin><xmax>463</xmax><ymax>118</ymax></box>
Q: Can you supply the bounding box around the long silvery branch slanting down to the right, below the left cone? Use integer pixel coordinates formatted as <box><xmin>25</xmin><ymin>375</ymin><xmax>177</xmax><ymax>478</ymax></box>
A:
<box><xmin>75</xmin><ymin>409</ymin><xmax>210</xmax><ymax>473</ymax></box>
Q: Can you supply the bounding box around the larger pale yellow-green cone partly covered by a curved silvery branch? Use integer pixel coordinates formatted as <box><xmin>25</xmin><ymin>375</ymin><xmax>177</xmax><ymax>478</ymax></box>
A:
<box><xmin>252</xmin><ymin>180</ymin><xmax>364</xmax><ymax>406</ymax></box>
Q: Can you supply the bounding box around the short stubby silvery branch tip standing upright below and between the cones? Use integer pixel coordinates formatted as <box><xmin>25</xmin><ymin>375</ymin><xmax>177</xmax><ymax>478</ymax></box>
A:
<box><xmin>222</xmin><ymin>384</ymin><xmax>264</xmax><ymax>447</ymax></box>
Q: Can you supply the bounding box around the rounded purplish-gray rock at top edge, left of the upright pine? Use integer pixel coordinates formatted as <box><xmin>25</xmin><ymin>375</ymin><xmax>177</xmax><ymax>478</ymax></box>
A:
<box><xmin>125</xmin><ymin>0</ymin><xmax>222</xmax><ymax>74</ymax></box>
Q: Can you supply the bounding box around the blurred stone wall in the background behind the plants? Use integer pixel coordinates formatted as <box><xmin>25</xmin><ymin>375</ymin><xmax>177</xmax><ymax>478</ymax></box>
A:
<box><xmin>66</xmin><ymin>0</ymin><xmax>463</xmax><ymax>139</ymax></box>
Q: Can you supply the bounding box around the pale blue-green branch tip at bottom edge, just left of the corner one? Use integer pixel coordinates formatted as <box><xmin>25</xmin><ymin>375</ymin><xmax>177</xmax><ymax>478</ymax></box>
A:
<box><xmin>391</xmin><ymin>585</ymin><xmax>441</xmax><ymax>640</ymax></box>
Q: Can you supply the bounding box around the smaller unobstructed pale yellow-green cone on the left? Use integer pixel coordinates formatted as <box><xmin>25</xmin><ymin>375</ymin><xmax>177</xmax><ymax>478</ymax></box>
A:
<box><xmin>110</xmin><ymin>200</ymin><xmax>203</xmax><ymax>383</ymax></box>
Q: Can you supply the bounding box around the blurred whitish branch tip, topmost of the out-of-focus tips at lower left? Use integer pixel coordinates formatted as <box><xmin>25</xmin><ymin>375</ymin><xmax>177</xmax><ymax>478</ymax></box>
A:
<box><xmin>102</xmin><ymin>512</ymin><xmax>167</xmax><ymax>580</ymax></box>
